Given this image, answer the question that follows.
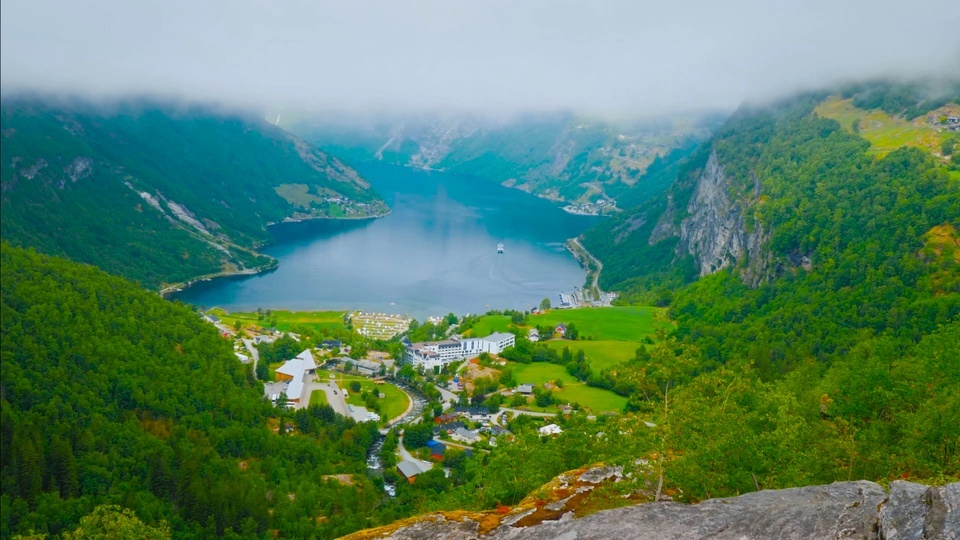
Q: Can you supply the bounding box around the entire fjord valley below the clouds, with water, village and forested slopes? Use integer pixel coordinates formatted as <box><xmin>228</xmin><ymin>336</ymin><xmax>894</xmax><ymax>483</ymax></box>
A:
<box><xmin>0</xmin><ymin>78</ymin><xmax>960</xmax><ymax>539</ymax></box>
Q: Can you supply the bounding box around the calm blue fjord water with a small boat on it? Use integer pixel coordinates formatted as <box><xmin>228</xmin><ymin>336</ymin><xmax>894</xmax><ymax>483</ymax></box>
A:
<box><xmin>175</xmin><ymin>163</ymin><xmax>598</xmax><ymax>319</ymax></box>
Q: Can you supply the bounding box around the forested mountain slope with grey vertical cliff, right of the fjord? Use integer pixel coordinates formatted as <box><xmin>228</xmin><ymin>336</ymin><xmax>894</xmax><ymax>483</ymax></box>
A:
<box><xmin>583</xmin><ymin>82</ymin><xmax>960</xmax><ymax>374</ymax></box>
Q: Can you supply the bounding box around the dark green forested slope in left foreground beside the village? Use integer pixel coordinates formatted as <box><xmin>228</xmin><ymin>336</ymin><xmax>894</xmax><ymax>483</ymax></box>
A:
<box><xmin>0</xmin><ymin>243</ymin><xmax>381</xmax><ymax>538</ymax></box>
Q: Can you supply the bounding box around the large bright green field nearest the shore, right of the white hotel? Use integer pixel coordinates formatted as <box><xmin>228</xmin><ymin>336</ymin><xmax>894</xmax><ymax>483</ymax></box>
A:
<box><xmin>528</xmin><ymin>306</ymin><xmax>670</xmax><ymax>342</ymax></box>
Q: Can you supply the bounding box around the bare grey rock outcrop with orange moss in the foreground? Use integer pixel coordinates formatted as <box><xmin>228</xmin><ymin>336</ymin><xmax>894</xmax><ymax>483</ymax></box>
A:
<box><xmin>349</xmin><ymin>471</ymin><xmax>960</xmax><ymax>540</ymax></box>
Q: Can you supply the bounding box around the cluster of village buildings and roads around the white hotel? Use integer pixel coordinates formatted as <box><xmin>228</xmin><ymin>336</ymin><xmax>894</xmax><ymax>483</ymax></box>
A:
<box><xmin>202</xmin><ymin>310</ymin><xmax>612</xmax><ymax>481</ymax></box>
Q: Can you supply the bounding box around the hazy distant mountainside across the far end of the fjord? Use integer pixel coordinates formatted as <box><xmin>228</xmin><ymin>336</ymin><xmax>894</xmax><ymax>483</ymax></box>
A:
<box><xmin>289</xmin><ymin>113</ymin><xmax>717</xmax><ymax>211</ymax></box>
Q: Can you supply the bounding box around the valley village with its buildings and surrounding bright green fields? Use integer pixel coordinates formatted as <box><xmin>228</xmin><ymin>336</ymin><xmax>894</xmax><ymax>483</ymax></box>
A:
<box><xmin>196</xmin><ymin>304</ymin><xmax>664</xmax><ymax>482</ymax></box>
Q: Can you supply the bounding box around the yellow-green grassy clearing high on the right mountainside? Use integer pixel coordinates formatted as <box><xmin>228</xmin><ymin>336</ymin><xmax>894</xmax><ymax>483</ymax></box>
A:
<box><xmin>816</xmin><ymin>96</ymin><xmax>955</xmax><ymax>156</ymax></box>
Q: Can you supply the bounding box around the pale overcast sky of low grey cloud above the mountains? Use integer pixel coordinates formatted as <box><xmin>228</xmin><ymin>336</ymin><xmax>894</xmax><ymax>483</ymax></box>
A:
<box><xmin>0</xmin><ymin>0</ymin><xmax>960</xmax><ymax>113</ymax></box>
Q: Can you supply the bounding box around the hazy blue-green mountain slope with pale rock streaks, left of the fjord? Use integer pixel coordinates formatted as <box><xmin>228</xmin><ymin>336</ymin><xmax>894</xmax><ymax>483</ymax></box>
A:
<box><xmin>0</xmin><ymin>99</ymin><xmax>386</xmax><ymax>287</ymax></box>
